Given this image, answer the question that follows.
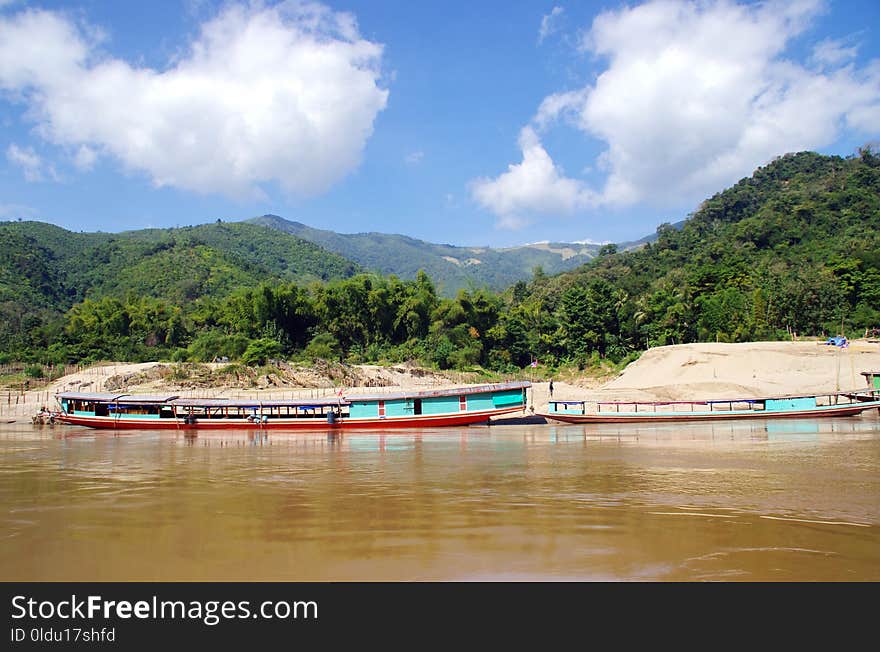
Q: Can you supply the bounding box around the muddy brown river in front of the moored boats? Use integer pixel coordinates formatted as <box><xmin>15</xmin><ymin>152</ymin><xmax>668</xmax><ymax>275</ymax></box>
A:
<box><xmin>0</xmin><ymin>413</ymin><xmax>880</xmax><ymax>581</ymax></box>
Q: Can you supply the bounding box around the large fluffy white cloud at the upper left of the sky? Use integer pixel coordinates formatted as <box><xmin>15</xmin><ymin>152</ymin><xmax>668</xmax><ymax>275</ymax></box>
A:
<box><xmin>0</xmin><ymin>2</ymin><xmax>388</xmax><ymax>196</ymax></box>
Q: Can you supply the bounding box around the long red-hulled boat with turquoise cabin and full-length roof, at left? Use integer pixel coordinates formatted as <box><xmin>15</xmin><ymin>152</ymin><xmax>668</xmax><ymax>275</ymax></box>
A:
<box><xmin>52</xmin><ymin>381</ymin><xmax>531</xmax><ymax>430</ymax></box>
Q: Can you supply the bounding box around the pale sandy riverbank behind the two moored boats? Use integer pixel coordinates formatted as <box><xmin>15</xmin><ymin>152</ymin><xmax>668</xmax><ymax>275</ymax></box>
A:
<box><xmin>6</xmin><ymin>340</ymin><xmax>880</xmax><ymax>421</ymax></box>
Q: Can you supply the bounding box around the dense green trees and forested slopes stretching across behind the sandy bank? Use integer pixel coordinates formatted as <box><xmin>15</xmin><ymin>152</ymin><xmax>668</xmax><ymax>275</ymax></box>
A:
<box><xmin>0</xmin><ymin>148</ymin><xmax>880</xmax><ymax>371</ymax></box>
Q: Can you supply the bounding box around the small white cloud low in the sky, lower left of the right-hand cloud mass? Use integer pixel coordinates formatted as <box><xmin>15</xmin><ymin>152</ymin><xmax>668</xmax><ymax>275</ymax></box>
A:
<box><xmin>471</xmin><ymin>127</ymin><xmax>594</xmax><ymax>228</ymax></box>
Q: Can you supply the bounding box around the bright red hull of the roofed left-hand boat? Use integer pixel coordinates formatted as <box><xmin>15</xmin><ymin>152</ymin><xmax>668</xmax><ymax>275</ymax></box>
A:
<box><xmin>54</xmin><ymin>405</ymin><xmax>524</xmax><ymax>432</ymax></box>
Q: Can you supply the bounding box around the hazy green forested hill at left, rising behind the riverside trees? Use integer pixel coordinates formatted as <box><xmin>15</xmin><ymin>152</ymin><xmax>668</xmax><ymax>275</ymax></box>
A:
<box><xmin>0</xmin><ymin>222</ymin><xmax>359</xmax><ymax>356</ymax></box>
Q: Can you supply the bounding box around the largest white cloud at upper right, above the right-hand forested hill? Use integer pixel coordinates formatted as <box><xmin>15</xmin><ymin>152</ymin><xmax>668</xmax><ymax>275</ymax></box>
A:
<box><xmin>474</xmin><ymin>0</ymin><xmax>880</xmax><ymax>221</ymax></box>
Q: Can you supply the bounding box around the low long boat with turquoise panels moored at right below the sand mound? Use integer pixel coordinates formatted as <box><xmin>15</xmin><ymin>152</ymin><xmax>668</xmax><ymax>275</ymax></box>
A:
<box><xmin>541</xmin><ymin>390</ymin><xmax>880</xmax><ymax>423</ymax></box>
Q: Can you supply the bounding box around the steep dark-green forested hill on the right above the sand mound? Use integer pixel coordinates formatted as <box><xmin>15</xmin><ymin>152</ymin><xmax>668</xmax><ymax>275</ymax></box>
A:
<box><xmin>508</xmin><ymin>149</ymin><xmax>880</xmax><ymax>357</ymax></box>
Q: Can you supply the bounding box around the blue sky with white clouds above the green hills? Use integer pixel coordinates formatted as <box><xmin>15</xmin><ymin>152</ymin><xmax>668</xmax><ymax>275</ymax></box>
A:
<box><xmin>0</xmin><ymin>0</ymin><xmax>880</xmax><ymax>246</ymax></box>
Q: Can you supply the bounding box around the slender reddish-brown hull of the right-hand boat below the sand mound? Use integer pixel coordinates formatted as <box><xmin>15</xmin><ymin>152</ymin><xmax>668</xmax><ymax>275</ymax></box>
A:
<box><xmin>541</xmin><ymin>401</ymin><xmax>880</xmax><ymax>423</ymax></box>
